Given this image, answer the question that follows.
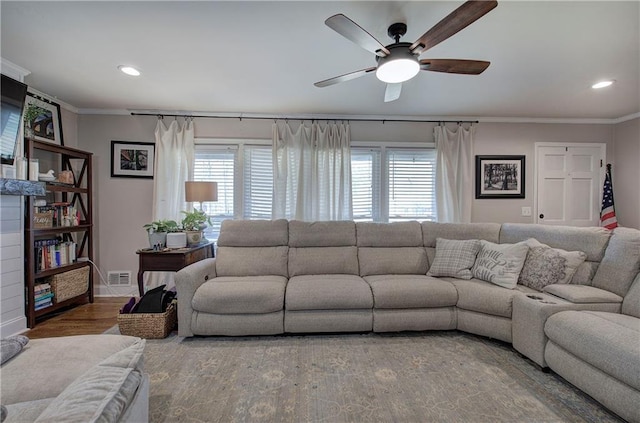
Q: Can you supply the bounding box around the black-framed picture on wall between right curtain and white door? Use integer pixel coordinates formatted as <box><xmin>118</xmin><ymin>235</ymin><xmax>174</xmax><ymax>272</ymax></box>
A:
<box><xmin>476</xmin><ymin>156</ymin><xmax>525</xmax><ymax>198</ymax></box>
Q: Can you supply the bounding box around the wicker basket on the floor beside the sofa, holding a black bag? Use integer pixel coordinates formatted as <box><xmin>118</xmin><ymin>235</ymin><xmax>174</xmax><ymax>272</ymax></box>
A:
<box><xmin>118</xmin><ymin>303</ymin><xmax>177</xmax><ymax>339</ymax></box>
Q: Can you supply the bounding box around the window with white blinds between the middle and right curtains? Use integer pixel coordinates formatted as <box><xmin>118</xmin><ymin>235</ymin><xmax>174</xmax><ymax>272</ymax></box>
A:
<box><xmin>351</xmin><ymin>146</ymin><xmax>436</xmax><ymax>222</ymax></box>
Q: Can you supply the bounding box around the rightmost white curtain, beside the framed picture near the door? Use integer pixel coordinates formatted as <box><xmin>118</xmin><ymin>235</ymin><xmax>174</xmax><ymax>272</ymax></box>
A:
<box><xmin>434</xmin><ymin>125</ymin><xmax>475</xmax><ymax>223</ymax></box>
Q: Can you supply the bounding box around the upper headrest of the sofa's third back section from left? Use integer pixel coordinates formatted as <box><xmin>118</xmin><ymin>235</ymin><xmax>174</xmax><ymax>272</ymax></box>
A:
<box><xmin>356</xmin><ymin>221</ymin><xmax>423</xmax><ymax>247</ymax></box>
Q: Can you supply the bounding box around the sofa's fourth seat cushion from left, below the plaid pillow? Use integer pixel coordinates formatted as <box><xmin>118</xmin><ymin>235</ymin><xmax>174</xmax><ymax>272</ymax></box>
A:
<box><xmin>447</xmin><ymin>278</ymin><xmax>536</xmax><ymax>319</ymax></box>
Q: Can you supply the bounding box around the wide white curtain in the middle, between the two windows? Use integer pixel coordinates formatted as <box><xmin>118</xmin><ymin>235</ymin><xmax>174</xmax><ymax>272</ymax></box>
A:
<box><xmin>273</xmin><ymin>122</ymin><xmax>353</xmax><ymax>221</ymax></box>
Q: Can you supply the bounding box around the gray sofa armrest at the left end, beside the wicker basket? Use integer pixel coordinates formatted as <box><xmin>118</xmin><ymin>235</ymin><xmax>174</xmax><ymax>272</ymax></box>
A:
<box><xmin>175</xmin><ymin>258</ymin><xmax>216</xmax><ymax>336</ymax></box>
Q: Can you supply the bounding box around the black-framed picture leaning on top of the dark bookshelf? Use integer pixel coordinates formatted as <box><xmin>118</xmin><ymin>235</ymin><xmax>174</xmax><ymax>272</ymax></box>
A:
<box><xmin>23</xmin><ymin>92</ymin><xmax>64</xmax><ymax>145</ymax></box>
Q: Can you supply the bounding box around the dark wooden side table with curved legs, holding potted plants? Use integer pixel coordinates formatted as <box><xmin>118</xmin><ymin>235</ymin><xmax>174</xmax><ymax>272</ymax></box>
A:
<box><xmin>136</xmin><ymin>241</ymin><xmax>214</xmax><ymax>296</ymax></box>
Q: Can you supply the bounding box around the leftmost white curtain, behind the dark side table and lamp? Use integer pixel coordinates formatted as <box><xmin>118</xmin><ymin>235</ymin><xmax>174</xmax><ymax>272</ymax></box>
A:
<box><xmin>143</xmin><ymin>119</ymin><xmax>195</xmax><ymax>289</ymax></box>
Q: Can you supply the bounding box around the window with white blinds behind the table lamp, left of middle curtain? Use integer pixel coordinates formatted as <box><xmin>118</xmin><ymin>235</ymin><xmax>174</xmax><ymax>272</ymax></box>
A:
<box><xmin>193</xmin><ymin>143</ymin><xmax>273</xmax><ymax>240</ymax></box>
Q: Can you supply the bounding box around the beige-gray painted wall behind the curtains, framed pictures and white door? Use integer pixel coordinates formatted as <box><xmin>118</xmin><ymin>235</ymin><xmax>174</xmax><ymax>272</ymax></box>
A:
<box><xmin>77</xmin><ymin>115</ymin><xmax>640</xmax><ymax>294</ymax></box>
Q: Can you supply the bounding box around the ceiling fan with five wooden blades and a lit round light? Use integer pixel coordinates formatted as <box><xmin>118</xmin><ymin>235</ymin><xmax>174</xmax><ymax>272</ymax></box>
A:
<box><xmin>314</xmin><ymin>0</ymin><xmax>498</xmax><ymax>102</ymax></box>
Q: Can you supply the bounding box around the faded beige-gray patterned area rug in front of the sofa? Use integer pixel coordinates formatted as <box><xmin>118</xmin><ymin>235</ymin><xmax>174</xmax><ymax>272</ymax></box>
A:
<box><xmin>110</xmin><ymin>330</ymin><xmax>622</xmax><ymax>423</ymax></box>
